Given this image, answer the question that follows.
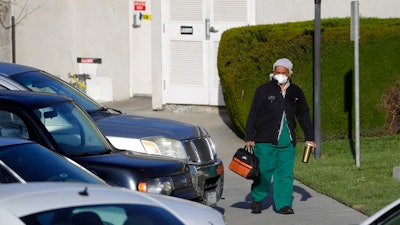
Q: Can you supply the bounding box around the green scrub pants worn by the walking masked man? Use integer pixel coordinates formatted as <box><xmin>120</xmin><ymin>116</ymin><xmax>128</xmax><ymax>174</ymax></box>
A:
<box><xmin>251</xmin><ymin>117</ymin><xmax>296</xmax><ymax>210</ymax></box>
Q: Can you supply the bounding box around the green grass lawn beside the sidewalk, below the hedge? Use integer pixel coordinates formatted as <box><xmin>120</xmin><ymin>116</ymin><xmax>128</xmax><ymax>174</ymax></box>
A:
<box><xmin>295</xmin><ymin>135</ymin><xmax>400</xmax><ymax>215</ymax></box>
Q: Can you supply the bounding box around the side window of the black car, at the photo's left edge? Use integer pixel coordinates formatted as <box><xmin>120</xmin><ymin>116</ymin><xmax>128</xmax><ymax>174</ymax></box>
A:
<box><xmin>0</xmin><ymin>110</ymin><xmax>29</xmax><ymax>139</ymax></box>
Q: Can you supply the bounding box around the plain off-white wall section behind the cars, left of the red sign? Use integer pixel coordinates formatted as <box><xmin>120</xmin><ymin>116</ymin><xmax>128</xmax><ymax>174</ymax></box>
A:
<box><xmin>14</xmin><ymin>0</ymin><xmax>132</xmax><ymax>101</ymax></box>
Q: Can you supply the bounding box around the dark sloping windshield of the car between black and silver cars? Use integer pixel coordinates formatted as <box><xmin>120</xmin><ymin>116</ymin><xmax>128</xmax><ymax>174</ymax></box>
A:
<box><xmin>0</xmin><ymin>143</ymin><xmax>104</xmax><ymax>184</ymax></box>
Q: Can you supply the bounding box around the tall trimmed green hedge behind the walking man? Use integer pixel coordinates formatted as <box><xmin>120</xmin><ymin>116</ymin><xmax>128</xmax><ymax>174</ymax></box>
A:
<box><xmin>218</xmin><ymin>18</ymin><xmax>400</xmax><ymax>140</ymax></box>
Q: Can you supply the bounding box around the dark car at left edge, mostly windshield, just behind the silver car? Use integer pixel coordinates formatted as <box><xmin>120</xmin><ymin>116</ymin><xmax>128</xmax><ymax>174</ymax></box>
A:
<box><xmin>0</xmin><ymin>137</ymin><xmax>106</xmax><ymax>185</ymax></box>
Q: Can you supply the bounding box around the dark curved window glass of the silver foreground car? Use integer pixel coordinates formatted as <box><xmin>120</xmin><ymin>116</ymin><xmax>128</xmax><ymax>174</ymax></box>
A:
<box><xmin>21</xmin><ymin>204</ymin><xmax>183</xmax><ymax>225</ymax></box>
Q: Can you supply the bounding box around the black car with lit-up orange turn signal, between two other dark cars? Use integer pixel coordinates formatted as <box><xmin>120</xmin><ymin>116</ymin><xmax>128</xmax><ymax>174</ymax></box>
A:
<box><xmin>0</xmin><ymin>90</ymin><xmax>197</xmax><ymax>199</ymax></box>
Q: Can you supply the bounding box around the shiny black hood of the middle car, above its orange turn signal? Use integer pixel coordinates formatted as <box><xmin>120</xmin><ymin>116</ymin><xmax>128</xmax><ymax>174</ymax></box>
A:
<box><xmin>72</xmin><ymin>151</ymin><xmax>190</xmax><ymax>177</ymax></box>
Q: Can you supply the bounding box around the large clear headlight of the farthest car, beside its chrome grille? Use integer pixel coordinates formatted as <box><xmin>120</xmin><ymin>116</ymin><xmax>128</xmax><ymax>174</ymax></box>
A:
<box><xmin>141</xmin><ymin>136</ymin><xmax>188</xmax><ymax>160</ymax></box>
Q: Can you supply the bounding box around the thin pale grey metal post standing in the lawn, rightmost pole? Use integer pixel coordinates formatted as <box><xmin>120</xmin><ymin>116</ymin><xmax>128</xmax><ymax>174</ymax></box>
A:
<box><xmin>351</xmin><ymin>0</ymin><xmax>360</xmax><ymax>167</ymax></box>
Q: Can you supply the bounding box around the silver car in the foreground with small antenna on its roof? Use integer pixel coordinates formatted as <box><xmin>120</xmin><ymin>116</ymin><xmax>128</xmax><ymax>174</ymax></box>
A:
<box><xmin>0</xmin><ymin>183</ymin><xmax>225</xmax><ymax>225</ymax></box>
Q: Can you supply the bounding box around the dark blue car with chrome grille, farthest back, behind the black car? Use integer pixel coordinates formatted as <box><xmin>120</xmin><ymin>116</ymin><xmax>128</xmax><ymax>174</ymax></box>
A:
<box><xmin>0</xmin><ymin>63</ymin><xmax>224</xmax><ymax>205</ymax></box>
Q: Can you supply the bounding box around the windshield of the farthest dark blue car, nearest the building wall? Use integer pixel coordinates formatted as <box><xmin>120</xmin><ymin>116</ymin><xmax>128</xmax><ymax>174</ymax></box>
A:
<box><xmin>11</xmin><ymin>71</ymin><xmax>104</xmax><ymax>112</ymax></box>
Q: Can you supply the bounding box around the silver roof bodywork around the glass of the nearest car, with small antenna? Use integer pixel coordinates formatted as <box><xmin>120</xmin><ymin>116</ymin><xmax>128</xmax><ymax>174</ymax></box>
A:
<box><xmin>0</xmin><ymin>182</ymin><xmax>226</xmax><ymax>225</ymax></box>
